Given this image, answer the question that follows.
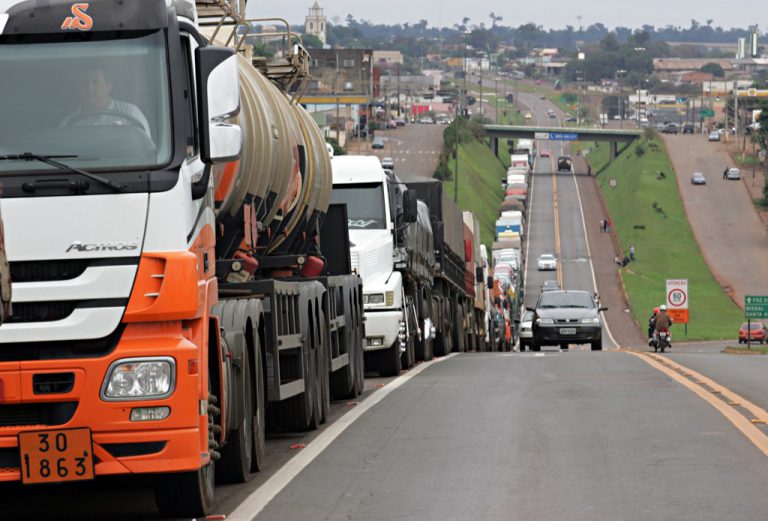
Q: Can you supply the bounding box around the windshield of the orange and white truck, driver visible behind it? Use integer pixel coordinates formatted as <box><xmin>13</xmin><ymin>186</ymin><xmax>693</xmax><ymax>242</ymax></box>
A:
<box><xmin>0</xmin><ymin>32</ymin><xmax>171</xmax><ymax>173</ymax></box>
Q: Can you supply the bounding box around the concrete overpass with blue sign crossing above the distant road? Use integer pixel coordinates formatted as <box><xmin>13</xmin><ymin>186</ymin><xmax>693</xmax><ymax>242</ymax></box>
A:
<box><xmin>483</xmin><ymin>125</ymin><xmax>643</xmax><ymax>160</ymax></box>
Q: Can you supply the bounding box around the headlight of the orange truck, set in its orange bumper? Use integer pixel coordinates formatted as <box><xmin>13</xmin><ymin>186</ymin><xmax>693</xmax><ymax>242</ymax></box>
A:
<box><xmin>101</xmin><ymin>357</ymin><xmax>176</xmax><ymax>401</ymax></box>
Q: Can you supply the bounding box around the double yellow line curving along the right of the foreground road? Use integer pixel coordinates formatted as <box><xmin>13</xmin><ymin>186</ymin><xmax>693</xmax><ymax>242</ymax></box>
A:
<box><xmin>625</xmin><ymin>350</ymin><xmax>768</xmax><ymax>456</ymax></box>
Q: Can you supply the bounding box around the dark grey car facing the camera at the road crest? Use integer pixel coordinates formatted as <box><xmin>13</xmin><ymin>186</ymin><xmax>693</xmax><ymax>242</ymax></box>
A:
<box><xmin>529</xmin><ymin>291</ymin><xmax>608</xmax><ymax>351</ymax></box>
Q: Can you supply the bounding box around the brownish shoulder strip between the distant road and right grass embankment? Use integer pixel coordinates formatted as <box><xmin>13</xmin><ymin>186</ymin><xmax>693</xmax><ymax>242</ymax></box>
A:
<box><xmin>574</xmin><ymin>157</ymin><xmax>646</xmax><ymax>348</ymax></box>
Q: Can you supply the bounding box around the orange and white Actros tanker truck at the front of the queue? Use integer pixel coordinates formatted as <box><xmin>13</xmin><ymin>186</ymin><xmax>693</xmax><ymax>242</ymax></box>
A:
<box><xmin>0</xmin><ymin>0</ymin><xmax>364</xmax><ymax>517</ymax></box>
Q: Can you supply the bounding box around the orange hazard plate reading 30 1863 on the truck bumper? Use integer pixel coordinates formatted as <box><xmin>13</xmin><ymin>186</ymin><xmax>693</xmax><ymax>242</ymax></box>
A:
<box><xmin>19</xmin><ymin>428</ymin><xmax>94</xmax><ymax>484</ymax></box>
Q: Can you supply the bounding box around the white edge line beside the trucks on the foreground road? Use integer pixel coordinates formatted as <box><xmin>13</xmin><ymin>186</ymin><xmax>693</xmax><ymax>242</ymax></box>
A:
<box><xmin>227</xmin><ymin>353</ymin><xmax>458</xmax><ymax>521</ymax></box>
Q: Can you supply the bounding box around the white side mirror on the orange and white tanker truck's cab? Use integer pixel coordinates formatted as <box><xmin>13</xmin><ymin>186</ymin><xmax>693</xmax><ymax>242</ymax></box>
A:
<box><xmin>195</xmin><ymin>45</ymin><xmax>243</xmax><ymax>164</ymax></box>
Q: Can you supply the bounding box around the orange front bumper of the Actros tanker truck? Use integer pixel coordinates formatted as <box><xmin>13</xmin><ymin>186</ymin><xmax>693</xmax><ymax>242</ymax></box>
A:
<box><xmin>0</xmin><ymin>323</ymin><xmax>210</xmax><ymax>481</ymax></box>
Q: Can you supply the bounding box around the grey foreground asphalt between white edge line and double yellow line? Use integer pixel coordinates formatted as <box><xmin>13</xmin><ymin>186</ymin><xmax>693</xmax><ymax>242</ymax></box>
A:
<box><xmin>256</xmin><ymin>352</ymin><xmax>768</xmax><ymax>521</ymax></box>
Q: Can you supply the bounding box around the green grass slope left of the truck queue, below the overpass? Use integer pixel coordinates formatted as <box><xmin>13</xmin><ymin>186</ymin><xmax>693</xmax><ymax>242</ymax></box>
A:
<box><xmin>443</xmin><ymin>140</ymin><xmax>506</xmax><ymax>250</ymax></box>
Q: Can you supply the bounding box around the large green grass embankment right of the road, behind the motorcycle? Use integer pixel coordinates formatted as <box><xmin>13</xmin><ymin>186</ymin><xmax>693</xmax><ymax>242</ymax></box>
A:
<box><xmin>587</xmin><ymin>138</ymin><xmax>743</xmax><ymax>341</ymax></box>
